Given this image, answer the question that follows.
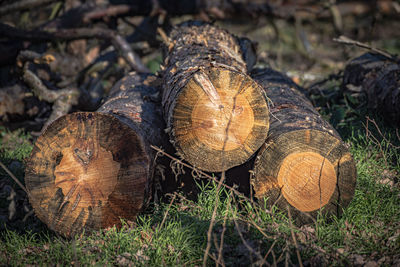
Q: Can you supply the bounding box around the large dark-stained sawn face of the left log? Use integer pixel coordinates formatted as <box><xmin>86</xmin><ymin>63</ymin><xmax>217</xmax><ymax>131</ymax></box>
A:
<box><xmin>25</xmin><ymin>112</ymin><xmax>150</xmax><ymax>237</ymax></box>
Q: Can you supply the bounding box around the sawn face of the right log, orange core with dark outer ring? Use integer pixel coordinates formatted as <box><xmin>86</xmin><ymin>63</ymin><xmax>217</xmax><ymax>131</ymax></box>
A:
<box><xmin>252</xmin><ymin>130</ymin><xmax>356</xmax><ymax>219</ymax></box>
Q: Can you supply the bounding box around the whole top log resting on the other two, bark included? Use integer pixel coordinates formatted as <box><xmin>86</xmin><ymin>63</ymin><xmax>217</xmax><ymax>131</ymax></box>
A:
<box><xmin>163</xmin><ymin>22</ymin><xmax>269</xmax><ymax>172</ymax></box>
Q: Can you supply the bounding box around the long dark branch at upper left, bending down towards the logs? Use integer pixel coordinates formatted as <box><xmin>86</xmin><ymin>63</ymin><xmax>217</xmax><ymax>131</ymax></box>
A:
<box><xmin>0</xmin><ymin>23</ymin><xmax>150</xmax><ymax>73</ymax></box>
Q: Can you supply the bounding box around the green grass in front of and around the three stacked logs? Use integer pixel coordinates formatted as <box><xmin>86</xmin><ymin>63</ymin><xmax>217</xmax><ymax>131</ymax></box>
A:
<box><xmin>0</xmin><ymin>71</ymin><xmax>400</xmax><ymax>266</ymax></box>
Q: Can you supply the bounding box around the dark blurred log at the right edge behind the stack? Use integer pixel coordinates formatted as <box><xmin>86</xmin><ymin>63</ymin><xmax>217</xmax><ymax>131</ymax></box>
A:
<box><xmin>342</xmin><ymin>53</ymin><xmax>400</xmax><ymax>127</ymax></box>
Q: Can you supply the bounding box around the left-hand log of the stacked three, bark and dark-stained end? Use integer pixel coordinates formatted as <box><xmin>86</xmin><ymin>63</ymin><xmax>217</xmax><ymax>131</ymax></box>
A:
<box><xmin>25</xmin><ymin>74</ymin><xmax>166</xmax><ymax>237</ymax></box>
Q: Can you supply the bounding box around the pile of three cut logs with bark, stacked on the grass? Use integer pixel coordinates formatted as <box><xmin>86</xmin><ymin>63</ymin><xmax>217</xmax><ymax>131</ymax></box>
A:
<box><xmin>25</xmin><ymin>22</ymin><xmax>362</xmax><ymax>236</ymax></box>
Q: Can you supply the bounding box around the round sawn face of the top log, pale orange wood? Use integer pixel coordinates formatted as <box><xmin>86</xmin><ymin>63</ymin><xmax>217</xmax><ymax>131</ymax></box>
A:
<box><xmin>173</xmin><ymin>67</ymin><xmax>269</xmax><ymax>171</ymax></box>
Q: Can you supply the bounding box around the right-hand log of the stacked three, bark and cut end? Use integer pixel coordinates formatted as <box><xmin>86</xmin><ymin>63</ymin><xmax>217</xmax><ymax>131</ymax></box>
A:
<box><xmin>251</xmin><ymin>69</ymin><xmax>356</xmax><ymax>222</ymax></box>
